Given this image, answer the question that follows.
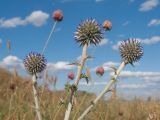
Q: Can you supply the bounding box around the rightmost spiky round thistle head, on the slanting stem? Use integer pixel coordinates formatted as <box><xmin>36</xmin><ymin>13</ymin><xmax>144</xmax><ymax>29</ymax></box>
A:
<box><xmin>119</xmin><ymin>39</ymin><xmax>143</xmax><ymax>64</ymax></box>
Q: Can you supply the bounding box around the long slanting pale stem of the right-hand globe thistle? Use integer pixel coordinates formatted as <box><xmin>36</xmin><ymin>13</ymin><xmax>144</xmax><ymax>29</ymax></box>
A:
<box><xmin>78</xmin><ymin>62</ymin><xmax>126</xmax><ymax>120</ymax></box>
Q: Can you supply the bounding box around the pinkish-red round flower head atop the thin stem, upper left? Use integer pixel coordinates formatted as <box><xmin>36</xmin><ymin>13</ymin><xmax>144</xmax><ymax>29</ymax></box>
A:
<box><xmin>53</xmin><ymin>10</ymin><xmax>63</xmax><ymax>22</ymax></box>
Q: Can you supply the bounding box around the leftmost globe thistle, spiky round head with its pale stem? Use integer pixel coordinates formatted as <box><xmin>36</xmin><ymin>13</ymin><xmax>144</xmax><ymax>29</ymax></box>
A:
<box><xmin>24</xmin><ymin>52</ymin><xmax>46</xmax><ymax>120</ymax></box>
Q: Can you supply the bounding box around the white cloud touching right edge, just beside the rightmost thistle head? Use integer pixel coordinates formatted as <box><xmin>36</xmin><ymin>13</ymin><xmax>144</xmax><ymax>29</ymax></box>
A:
<box><xmin>137</xmin><ymin>36</ymin><xmax>160</xmax><ymax>45</ymax></box>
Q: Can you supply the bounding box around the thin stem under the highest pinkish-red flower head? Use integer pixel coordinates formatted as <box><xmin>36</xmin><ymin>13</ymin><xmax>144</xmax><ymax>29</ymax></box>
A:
<box><xmin>42</xmin><ymin>21</ymin><xmax>58</xmax><ymax>55</ymax></box>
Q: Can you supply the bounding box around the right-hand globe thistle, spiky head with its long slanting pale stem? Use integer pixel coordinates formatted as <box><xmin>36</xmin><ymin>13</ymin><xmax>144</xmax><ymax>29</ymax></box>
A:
<box><xmin>78</xmin><ymin>39</ymin><xmax>143</xmax><ymax>120</ymax></box>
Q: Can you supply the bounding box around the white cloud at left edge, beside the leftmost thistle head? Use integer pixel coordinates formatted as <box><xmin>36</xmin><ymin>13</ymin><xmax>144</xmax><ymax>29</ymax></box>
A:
<box><xmin>0</xmin><ymin>55</ymin><xmax>24</xmax><ymax>69</ymax></box>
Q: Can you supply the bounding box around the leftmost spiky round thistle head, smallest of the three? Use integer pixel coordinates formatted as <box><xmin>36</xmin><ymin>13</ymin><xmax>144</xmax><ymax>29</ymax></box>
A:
<box><xmin>24</xmin><ymin>52</ymin><xmax>46</xmax><ymax>75</ymax></box>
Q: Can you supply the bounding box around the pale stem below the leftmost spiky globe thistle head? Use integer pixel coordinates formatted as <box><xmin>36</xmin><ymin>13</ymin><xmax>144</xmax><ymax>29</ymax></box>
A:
<box><xmin>32</xmin><ymin>75</ymin><xmax>42</xmax><ymax>120</ymax></box>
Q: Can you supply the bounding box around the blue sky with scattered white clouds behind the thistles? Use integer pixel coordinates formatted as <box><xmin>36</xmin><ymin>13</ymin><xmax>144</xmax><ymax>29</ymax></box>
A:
<box><xmin>0</xmin><ymin>0</ymin><xmax>160</xmax><ymax>97</ymax></box>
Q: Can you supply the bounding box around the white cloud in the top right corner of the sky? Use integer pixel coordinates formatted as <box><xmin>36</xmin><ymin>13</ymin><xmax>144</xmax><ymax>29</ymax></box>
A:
<box><xmin>139</xmin><ymin>0</ymin><xmax>159</xmax><ymax>12</ymax></box>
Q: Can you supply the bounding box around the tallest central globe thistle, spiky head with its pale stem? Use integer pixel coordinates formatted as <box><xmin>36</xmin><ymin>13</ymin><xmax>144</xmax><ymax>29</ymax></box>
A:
<box><xmin>64</xmin><ymin>19</ymin><xmax>103</xmax><ymax>120</ymax></box>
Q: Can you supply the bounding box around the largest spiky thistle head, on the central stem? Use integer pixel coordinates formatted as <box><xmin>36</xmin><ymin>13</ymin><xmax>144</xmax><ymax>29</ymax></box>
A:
<box><xmin>74</xmin><ymin>19</ymin><xmax>103</xmax><ymax>46</ymax></box>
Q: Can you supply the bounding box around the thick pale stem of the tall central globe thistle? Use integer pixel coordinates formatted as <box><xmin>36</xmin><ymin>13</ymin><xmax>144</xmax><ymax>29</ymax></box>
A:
<box><xmin>64</xmin><ymin>44</ymin><xmax>88</xmax><ymax>120</ymax></box>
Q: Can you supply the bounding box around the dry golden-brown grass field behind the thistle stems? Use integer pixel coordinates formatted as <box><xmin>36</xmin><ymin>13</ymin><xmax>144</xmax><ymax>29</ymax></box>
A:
<box><xmin>0</xmin><ymin>69</ymin><xmax>160</xmax><ymax>120</ymax></box>
